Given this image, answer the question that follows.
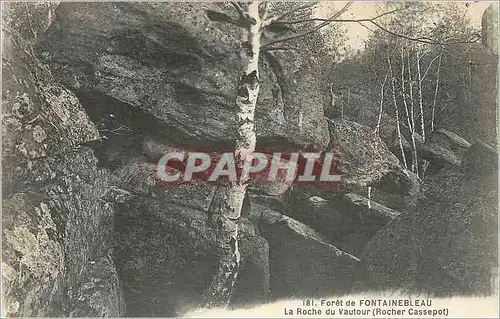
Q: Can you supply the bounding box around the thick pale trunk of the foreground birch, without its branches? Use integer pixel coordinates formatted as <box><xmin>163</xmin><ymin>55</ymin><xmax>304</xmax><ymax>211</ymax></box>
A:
<box><xmin>203</xmin><ymin>2</ymin><xmax>261</xmax><ymax>308</ymax></box>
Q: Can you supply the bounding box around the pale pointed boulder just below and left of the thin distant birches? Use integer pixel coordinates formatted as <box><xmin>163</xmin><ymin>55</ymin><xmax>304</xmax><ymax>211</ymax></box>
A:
<box><xmin>328</xmin><ymin>119</ymin><xmax>420</xmax><ymax>195</ymax></box>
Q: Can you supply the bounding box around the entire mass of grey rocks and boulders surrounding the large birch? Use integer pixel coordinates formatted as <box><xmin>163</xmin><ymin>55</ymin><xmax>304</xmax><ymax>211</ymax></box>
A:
<box><xmin>2</xmin><ymin>2</ymin><xmax>498</xmax><ymax>317</ymax></box>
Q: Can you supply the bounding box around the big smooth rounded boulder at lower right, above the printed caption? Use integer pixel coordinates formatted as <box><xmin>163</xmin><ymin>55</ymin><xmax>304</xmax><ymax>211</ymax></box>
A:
<box><xmin>362</xmin><ymin>162</ymin><xmax>498</xmax><ymax>296</ymax></box>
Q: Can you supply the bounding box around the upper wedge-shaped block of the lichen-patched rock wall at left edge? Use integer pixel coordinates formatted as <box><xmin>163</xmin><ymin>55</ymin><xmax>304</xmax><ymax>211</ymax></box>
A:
<box><xmin>2</xmin><ymin>29</ymin><xmax>98</xmax><ymax>176</ymax></box>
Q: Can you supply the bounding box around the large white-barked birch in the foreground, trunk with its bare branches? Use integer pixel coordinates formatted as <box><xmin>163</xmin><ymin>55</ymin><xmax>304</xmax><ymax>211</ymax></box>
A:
<box><xmin>202</xmin><ymin>1</ymin><xmax>353</xmax><ymax>308</ymax></box>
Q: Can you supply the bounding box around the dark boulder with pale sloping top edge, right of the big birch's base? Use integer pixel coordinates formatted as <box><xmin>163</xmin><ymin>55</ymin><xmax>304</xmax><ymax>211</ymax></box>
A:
<box><xmin>250</xmin><ymin>205</ymin><xmax>359</xmax><ymax>298</ymax></box>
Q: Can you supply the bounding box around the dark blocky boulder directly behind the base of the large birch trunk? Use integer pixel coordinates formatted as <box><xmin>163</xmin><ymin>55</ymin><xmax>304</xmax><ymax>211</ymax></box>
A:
<box><xmin>116</xmin><ymin>198</ymin><xmax>269</xmax><ymax>317</ymax></box>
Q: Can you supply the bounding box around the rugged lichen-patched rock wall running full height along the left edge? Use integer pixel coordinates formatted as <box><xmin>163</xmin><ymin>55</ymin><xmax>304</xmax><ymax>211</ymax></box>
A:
<box><xmin>2</xmin><ymin>5</ymin><xmax>125</xmax><ymax>317</ymax></box>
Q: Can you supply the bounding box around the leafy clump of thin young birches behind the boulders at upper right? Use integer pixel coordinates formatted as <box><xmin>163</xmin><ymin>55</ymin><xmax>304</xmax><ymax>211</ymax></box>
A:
<box><xmin>330</xmin><ymin>2</ymin><xmax>479</xmax><ymax>174</ymax></box>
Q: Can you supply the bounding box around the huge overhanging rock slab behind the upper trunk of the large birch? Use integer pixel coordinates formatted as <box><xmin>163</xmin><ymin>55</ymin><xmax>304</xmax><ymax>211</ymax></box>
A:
<box><xmin>39</xmin><ymin>3</ymin><xmax>329</xmax><ymax>150</ymax></box>
